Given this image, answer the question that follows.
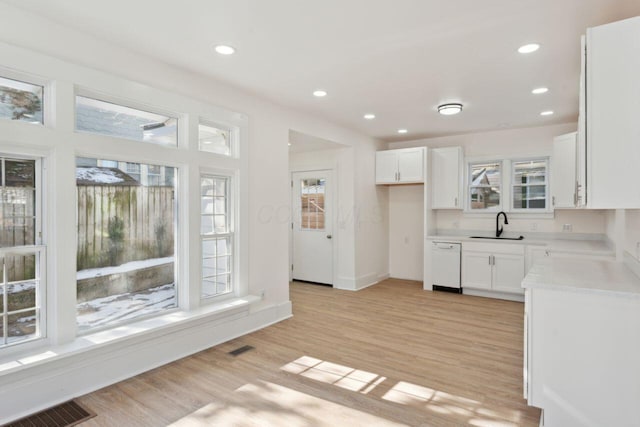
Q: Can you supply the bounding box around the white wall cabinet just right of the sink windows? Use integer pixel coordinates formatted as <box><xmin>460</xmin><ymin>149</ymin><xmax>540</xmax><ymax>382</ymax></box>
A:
<box><xmin>551</xmin><ymin>132</ymin><xmax>577</xmax><ymax>208</ymax></box>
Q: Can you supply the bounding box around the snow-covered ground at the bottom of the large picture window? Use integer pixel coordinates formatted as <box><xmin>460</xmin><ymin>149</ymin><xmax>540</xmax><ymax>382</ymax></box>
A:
<box><xmin>77</xmin><ymin>283</ymin><xmax>177</xmax><ymax>330</ymax></box>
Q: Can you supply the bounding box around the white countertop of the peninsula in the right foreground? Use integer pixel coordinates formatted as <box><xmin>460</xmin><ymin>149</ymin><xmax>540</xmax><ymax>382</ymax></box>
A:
<box><xmin>522</xmin><ymin>258</ymin><xmax>640</xmax><ymax>298</ymax></box>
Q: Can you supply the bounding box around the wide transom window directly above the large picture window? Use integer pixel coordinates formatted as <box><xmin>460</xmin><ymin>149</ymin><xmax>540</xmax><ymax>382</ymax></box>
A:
<box><xmin>76</xmin><ymin>96</ymin><xmax>178</xmax><ymax>146</ymax></box>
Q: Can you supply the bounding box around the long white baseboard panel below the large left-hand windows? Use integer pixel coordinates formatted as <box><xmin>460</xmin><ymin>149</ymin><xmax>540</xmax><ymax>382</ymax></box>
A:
<box><xmin>0</xmin><ymin>301</ymin><xmax>292</xmax><ymax>425</ymax></box>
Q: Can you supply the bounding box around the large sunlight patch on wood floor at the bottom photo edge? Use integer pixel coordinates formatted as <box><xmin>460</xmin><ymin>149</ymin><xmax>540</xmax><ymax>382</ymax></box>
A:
<box><xmin>170</xmin><ymin>381</ymin><xmax>402</xmax><ymax>427</ymax></box>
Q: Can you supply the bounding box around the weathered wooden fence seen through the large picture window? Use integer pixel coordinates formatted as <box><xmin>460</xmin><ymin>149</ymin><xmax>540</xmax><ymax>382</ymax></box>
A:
<box><xmin>77</xmin><ymin>185</ymin><xmax>175</xmax><ymax>270</ymax></box>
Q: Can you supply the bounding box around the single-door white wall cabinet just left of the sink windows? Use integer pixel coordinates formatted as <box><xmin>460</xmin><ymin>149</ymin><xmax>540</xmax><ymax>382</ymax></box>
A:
<box><xmin>430</xmin><ymin>147</ymin><xmax>464</xmax><ymax>209</ymax></box>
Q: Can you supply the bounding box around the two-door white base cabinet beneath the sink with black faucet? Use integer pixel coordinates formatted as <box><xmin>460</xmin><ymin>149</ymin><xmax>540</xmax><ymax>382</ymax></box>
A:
<box><xmin>462</xmin><ymin>242</ymin><xmax>524</xmax><ymax>295</ymax></box>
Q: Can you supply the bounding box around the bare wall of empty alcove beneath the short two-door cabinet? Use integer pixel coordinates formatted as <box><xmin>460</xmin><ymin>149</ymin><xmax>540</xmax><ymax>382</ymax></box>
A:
<box><xmin>389</xmin><ymin>185</ymin><xmax>424</xmax><ymax>281</ymax></box>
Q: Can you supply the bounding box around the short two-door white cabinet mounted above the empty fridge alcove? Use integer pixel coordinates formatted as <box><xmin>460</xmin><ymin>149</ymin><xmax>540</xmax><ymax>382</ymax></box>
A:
<box><xmin>376</xmin><ymin>147</ymin><xmax>426</xmax><ymax>184</ymax></box>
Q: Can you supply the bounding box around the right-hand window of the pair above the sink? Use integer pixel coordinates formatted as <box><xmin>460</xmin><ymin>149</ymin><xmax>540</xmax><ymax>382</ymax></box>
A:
<box><xmin>511</xmin><ymin>159</ymin><xmax>549</xmax><ymax>210</ymax></box>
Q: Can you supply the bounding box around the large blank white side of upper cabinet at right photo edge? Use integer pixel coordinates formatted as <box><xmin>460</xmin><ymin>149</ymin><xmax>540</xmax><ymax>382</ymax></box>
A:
<box><xmin>580</xmin><ymin>17</ymin><xmax>640</xmax><ymax>209</ymax></box>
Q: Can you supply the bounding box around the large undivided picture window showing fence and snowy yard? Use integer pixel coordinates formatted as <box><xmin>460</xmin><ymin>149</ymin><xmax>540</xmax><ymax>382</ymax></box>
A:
<box><xmin>76</xmin><ymin>158</ymin><xmax>177</xmax><ymax>331</ymax></box>
